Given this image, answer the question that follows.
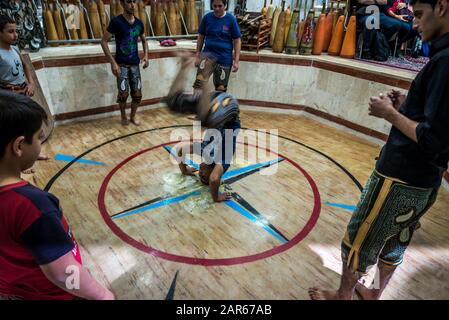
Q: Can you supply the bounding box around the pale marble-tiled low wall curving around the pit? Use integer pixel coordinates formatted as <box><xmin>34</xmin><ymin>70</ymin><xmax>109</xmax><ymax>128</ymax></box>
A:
<box><xmin>37</xmin><ymin>57</ymin><xmax>408</xmax><ymax>134</ymax></box>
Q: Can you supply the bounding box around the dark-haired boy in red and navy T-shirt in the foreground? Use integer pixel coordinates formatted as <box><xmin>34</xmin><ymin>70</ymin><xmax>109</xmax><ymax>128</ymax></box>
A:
<box><xmin>0</xmin><ymin>90</ymin><xmax>114</xmax><ymax>300</ymax></box>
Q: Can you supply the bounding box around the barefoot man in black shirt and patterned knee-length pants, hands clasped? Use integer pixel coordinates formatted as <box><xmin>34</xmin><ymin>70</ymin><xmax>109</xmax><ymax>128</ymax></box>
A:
<box><xmin>309</xmin><ymin>0</ymin><xmax>449</xmax><ymax>299</ymax></box>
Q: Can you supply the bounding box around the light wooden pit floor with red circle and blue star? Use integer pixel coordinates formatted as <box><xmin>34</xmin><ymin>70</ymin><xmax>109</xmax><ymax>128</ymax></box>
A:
<box><xmin>29</xmin><ymin>109</ymin><xmax>449</xmax><ymax>299</ymax></box>
